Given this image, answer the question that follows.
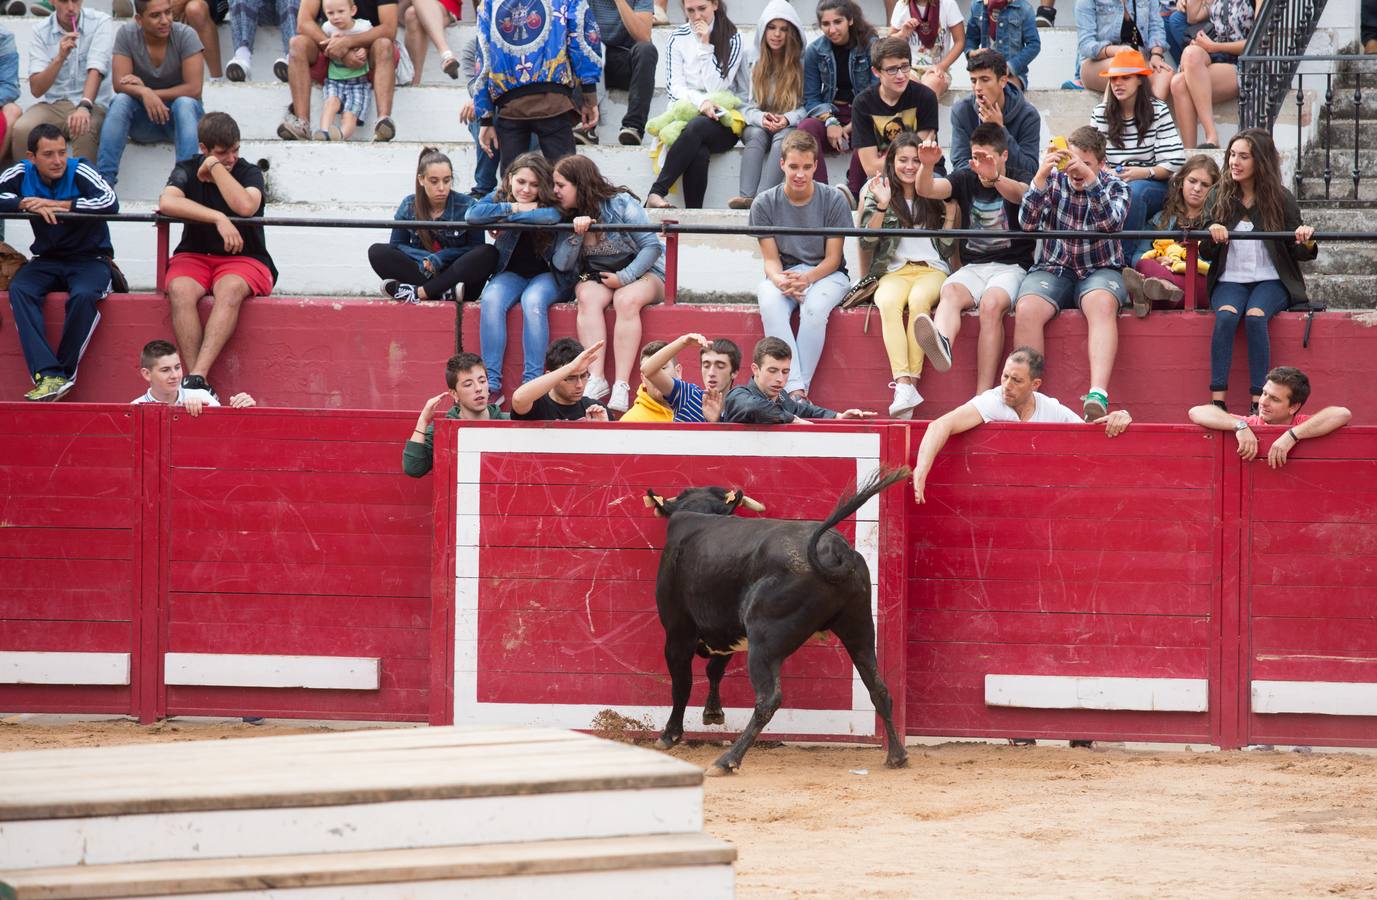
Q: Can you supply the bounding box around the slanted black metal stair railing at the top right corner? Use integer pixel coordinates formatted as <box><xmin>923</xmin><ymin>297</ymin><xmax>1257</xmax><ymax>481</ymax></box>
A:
<box><xmin>1238</xmin><ymin>0</ymin><xmax>1326</xmax><ymax>131</ymax></box>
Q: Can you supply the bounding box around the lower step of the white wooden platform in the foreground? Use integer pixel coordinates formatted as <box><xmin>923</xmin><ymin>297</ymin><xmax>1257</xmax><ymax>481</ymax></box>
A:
<box><xmin>0</xmin><ymin>834</ymin><xmax>737</xmax><ymax>900</ymax></box>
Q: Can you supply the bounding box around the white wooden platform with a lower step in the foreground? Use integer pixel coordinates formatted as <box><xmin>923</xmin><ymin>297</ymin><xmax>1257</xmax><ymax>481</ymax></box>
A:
<box><xmin>0</xmin><ymin>727</ymin><xmax>734</xmax><ymax>897</ymax></box>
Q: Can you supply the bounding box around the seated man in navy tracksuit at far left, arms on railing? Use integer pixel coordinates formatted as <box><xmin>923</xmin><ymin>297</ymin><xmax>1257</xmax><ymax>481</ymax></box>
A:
<box><xmin>0</xmin><ymin>125</ymin><xmax>120</xmax><ymax>400</ymax></box>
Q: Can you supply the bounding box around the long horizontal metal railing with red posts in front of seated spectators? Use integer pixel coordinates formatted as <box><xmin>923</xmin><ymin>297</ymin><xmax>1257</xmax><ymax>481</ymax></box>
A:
<box><xmin>0</xmin><ymin>212</ymin><xmax>1377</xmax><ymax>317</ymax></box>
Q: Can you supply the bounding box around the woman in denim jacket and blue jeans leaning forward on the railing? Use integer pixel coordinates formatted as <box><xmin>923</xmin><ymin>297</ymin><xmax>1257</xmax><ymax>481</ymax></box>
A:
<box><xmin>468</xmin><ymin>153</ymin><xmax>573</xmax><ymax>406</ymax></box>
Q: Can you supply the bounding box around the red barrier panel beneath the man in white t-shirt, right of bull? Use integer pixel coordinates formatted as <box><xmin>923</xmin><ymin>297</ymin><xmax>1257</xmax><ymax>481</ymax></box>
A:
<box><xmin>907</xmin><ymin>425</ymin><xmax>1221</xmax><ymax>743</ymax></box>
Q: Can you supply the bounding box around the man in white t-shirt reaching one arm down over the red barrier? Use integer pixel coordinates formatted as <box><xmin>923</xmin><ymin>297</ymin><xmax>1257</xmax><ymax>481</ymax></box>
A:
<box><xmin>913</xmin><ymin>347</ymin><xmax>1133</xmax><ymax>504</ymax></box>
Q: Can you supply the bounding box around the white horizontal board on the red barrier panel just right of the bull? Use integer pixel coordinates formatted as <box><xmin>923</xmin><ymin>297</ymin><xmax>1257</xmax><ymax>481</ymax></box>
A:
<box><xmin>985</xmin><ymin>674</ymin><xmax>1209</xmax><ymax>713</ymax></box>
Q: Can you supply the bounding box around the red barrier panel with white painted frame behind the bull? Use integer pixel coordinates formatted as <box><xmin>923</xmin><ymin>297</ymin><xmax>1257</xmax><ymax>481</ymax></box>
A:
<box><xmin>435</xmin><ymin>422</ymin><xmax>903</xmax><ymax>740</ymax></box>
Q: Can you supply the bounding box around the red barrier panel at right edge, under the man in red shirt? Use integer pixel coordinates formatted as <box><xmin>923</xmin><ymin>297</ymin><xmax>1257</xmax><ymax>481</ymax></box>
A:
<box><xmin>1238</xmin><ymin>428</ymin><xmax>1377</xmax><ymax>746</ymax></box>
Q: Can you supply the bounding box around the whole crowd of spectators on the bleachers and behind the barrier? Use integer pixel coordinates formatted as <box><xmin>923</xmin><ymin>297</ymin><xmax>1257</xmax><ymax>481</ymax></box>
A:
<box><xmin>0</xmin><ymin>0</ymin><xmax>1349</xmax><ymax>459</ymax></box>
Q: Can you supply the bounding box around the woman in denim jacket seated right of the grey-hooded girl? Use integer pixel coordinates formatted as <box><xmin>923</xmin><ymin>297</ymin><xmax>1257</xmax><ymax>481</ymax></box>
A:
<box><xmin>799</xmin><ymin>0</ymin><xmax>879</xmax><ymax>206</ymax></box>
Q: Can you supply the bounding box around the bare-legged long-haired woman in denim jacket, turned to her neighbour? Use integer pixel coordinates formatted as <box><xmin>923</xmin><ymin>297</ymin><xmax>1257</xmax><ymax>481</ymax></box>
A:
<box><xmin>555</xmin><ymin>156</ymin><xmax>665</xmax><ymax>413</ymax></box>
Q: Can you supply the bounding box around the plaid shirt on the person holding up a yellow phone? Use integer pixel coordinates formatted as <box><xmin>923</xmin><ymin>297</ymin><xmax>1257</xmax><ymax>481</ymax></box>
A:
<box><xmin>1019</xmin><ymin>169</ymin><xmax>1129</xmax><ymax>281</ymax></box>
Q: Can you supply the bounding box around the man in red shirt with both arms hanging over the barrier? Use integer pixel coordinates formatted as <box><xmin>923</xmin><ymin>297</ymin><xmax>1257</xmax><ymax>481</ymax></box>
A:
<box><xmin>1190</xmin><ymin>366</ymin><xmax>1354</xmax><ymax>469</ymax></box>
